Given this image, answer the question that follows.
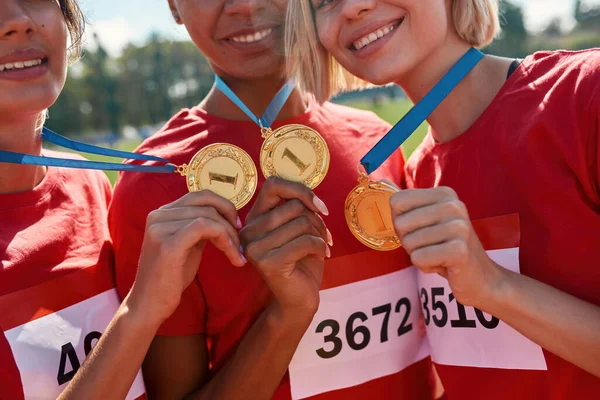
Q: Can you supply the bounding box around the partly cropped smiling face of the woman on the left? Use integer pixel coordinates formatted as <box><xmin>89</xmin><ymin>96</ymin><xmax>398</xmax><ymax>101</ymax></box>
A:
<box><xmin>0</xmin><ymin>0</ymin><xmax>68</xmax><ymax>118</ymax></box>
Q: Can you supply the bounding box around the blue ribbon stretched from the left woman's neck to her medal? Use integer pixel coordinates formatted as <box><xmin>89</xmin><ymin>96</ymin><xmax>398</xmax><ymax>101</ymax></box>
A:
<box><xmin>0</xmin><ymin>128</ymin><xmax>175</xmax><ymax>173</ymax></box>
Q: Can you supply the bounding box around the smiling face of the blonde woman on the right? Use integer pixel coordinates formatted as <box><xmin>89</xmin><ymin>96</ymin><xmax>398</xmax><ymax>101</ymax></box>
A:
<box><xmin>310</xmin><ymin>0</ymin><xmax>459</xmax><ymax>85</ymax></box>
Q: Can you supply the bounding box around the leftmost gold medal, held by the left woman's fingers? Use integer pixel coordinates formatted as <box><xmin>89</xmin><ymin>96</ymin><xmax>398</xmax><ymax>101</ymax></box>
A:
<box><xmin>177</xmin><ymin>143</ymin><xmax>258</xmax><ymax>210</ymax></box>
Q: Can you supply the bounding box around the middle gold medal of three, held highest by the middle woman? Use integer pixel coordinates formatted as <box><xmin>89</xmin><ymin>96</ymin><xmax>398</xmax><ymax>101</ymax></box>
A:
<box><xmin>260</xmin><ymin>125</ymin><xmax>330</xmax><ymax>189</ymax></box>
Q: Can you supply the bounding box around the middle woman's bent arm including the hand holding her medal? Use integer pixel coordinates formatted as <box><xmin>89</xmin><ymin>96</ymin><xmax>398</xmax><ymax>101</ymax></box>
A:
<box><xmin>144</xmin><ymin>179</ymin><xmax>328</xmax><ymax>400</ymax></box>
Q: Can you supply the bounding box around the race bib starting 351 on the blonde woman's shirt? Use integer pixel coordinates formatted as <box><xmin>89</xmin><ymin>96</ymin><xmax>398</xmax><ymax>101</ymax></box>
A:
<box><xmin>418</xmin><ymin>216</ymin><xmax>547</xmax><ymax>370</ymax></box>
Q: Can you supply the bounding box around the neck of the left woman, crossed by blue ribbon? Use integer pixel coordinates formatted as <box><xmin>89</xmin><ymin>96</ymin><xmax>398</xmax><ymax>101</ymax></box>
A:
<box><xmin>0</xmin><ymin>111</ymin><xmax>46</xmax><ymax>194</ymax></box>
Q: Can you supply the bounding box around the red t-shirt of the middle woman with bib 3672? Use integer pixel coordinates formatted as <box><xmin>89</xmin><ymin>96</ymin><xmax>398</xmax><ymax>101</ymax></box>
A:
<box><xmin>109</xmin><ymin>103</ymin><xmax>431</xmax><ymax>399</ymax></box>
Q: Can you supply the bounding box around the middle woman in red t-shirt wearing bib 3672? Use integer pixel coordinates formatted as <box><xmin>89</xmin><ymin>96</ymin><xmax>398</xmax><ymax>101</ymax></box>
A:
<box><xmin>109</xmin><ymin>0</ymin><xmax>432</xmax><ymax>399</ymax></box>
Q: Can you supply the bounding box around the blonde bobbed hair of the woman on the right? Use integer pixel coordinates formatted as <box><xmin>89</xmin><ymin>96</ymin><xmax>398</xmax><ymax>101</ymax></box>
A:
<box><xmin>285</xmin><ymin>0</ymin><xmax>500</xmax><ymax>103</ymax></box>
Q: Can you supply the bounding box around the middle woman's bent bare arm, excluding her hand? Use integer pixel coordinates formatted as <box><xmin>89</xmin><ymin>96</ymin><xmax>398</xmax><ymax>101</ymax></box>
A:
<box><xmin>144</xmin><ymin>305</ymin><xmax>311</xmax><ymax>399</ymax></box>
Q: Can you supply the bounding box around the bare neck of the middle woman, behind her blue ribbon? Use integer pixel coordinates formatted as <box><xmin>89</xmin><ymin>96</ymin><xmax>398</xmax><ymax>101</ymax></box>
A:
<box><xmin>200</xmin><ymin>72</ymin><xmax>307</xmax><ymax>121</ymax></box>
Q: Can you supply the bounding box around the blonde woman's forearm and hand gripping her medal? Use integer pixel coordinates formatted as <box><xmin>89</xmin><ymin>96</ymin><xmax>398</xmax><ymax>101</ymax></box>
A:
<box><xmin>391</xmin><ymin>187</ymin><xmax>600</xmax><ymax>377</ymax></box>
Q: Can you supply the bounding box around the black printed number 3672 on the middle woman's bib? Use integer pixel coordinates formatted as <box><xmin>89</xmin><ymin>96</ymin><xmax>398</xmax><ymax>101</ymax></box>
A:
<box><xmin>316</xmin><ymin>298</ymin><xmax>412</xmax><ymax>359</ymax></box>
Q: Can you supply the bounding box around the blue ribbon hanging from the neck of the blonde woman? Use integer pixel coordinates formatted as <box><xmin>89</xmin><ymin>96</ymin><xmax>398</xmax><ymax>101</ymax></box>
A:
<box><xmin>360</xmin><ymin>48</ymin><xmax>484</xmax><ymax>174</ymax></box>
